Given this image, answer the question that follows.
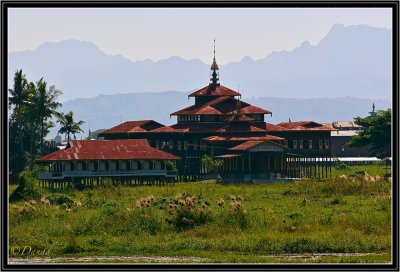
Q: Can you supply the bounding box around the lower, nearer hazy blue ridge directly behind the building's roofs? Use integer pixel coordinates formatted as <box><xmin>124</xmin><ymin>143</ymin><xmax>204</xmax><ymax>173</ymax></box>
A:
<box><xmin>49</xmin><ymin>91</ymin><xmax>390</xmax><ymax>139</ymax></box>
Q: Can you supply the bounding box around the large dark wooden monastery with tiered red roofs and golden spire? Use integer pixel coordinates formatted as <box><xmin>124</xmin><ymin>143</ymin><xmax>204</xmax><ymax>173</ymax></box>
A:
<box><xmin>99</xmin><ymin>47</ymin><xmax>335</xmax><ymax>181</ymax></box>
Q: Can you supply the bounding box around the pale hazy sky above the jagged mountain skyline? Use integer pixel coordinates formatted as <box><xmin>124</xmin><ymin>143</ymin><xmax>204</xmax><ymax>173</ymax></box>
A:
<box><xmin>8</xmin><ymin>8</ymin><xmax>392</xmax><ymax>64</ymax></box>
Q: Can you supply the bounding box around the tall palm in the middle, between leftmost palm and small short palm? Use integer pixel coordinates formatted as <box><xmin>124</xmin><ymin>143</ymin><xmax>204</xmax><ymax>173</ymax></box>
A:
<box><xmin>32</xmin><ymin>78</ymin><xmax>62</xmax><ymax>151</ymax></box>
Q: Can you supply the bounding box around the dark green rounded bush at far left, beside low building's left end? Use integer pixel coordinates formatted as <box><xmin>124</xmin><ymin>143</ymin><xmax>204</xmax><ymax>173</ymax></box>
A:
<box><xmin>10</xmin><ymin>170</ymin><xmax>41</xmax><ymax>202</ymax></box>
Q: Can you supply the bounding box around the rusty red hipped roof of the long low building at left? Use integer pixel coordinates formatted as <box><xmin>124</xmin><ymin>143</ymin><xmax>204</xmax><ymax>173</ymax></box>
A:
<box><xmin>38</xmin><ymin>139</ymin><xmax>180</xmax><ymax>162</ymax></box>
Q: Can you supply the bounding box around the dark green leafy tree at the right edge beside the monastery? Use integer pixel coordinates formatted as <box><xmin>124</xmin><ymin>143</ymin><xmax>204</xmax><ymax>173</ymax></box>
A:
<box><xmin>347</xmin><ymin>109</ymin><xmax>392</xmax><ymax>159</ymax></box>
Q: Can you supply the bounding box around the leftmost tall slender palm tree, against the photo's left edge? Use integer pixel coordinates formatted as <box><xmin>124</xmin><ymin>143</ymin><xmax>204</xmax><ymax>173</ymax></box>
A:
<box><xmin>8</xmin><ymin>70</ymin><xmax>28</xmax><ymax>153</ymax></box>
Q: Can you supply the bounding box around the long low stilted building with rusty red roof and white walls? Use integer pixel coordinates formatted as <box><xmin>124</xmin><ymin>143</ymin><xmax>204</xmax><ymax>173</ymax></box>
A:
<box><xmin>37</xmin><ymin>139</ymin><xmax>180</xmax><ymax>180</ymax></box>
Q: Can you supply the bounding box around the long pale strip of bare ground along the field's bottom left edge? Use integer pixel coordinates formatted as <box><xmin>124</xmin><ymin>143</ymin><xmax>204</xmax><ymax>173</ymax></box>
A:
<box><xmin>8</xmin><ymin>256</ymin><xmax>207</xmax><ymax>264</ymax></box>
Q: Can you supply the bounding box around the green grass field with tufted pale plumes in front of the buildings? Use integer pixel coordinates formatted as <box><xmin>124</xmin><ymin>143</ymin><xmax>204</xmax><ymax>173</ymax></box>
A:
<box><xmin>9</xmin><ymin>166</ymin><xmax>391</xmax><ymax>263</ymax></box>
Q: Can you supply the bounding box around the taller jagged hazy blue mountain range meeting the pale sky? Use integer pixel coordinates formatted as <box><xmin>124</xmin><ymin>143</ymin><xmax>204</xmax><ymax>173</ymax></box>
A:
<box><xmin>8</xmin><ymin>25</ymin><xmax>392</xmax><ymax>101</ymax></box>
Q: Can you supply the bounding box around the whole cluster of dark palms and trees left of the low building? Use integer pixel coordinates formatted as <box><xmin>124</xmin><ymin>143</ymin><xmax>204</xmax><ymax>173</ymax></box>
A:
<box><xmin>8</xmin><ymin>70</ymin><xmax>83</xmax><ymax>173</ymax></box>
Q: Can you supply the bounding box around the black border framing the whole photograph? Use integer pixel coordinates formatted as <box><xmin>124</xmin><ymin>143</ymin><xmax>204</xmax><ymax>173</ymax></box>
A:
<box><xmin>0</xmin><ymin>0</ymin><xmax>400</xmax><ymax>271</ymax></box>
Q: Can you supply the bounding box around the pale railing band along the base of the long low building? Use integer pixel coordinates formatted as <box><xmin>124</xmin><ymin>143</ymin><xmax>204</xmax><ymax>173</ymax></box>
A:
<box><xmin>39</xmin><ymin>170</ymin><xmax>176</xmax><ymax>179</ymax></box>
